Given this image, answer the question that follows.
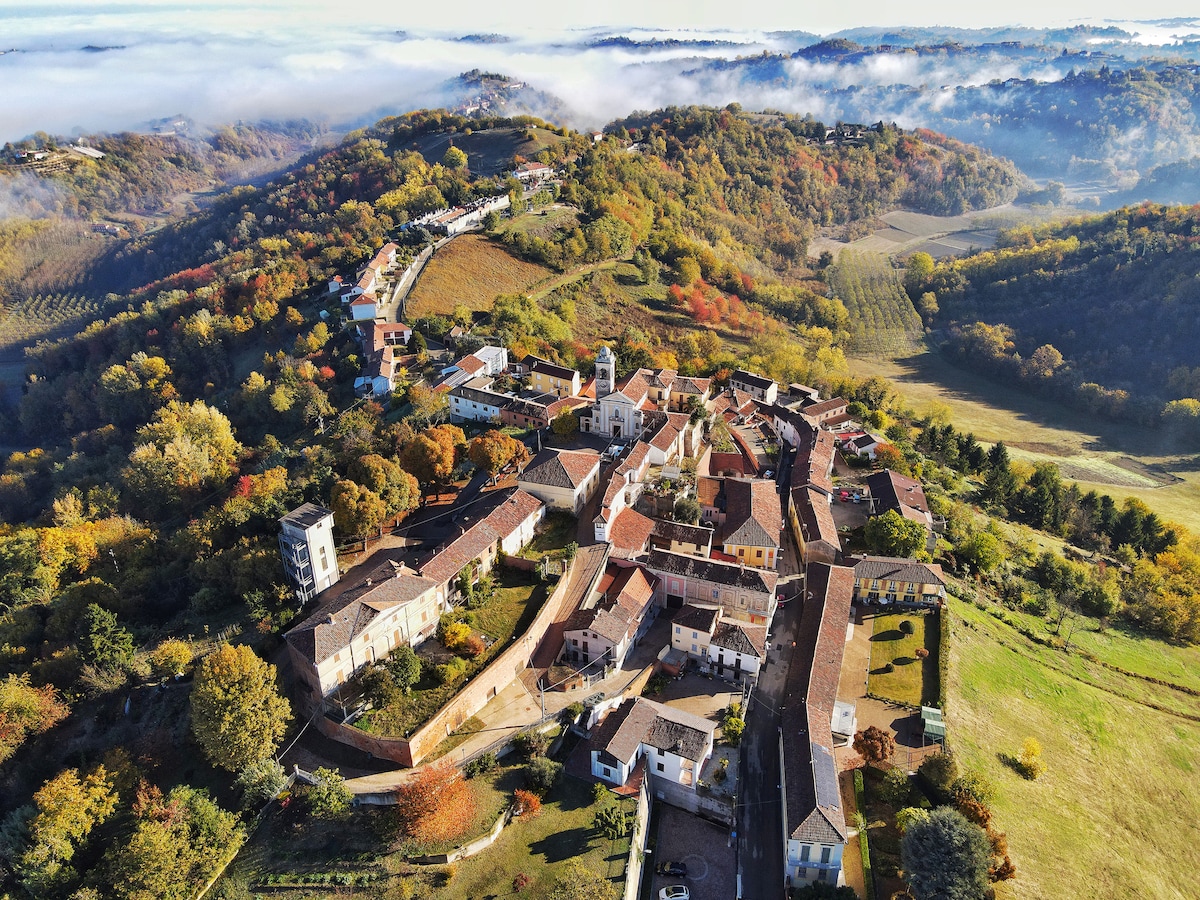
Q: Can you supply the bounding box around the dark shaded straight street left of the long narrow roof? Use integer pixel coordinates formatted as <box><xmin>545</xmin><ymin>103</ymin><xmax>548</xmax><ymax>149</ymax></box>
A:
<box><xmin>738</xmin><ymin>578</ymin><xmax>800</xmax><ymax>900</ymax></box>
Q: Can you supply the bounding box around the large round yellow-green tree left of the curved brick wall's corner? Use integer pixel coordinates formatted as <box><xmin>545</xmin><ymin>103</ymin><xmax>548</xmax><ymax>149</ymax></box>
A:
<box><xmin>192</xmin><ymin>644</ymin><xmax>292</xmax><ymax>772</ymax></box>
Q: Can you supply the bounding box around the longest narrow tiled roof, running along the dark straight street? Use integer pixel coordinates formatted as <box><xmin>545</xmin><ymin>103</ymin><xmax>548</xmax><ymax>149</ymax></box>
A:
<box><xmin>782</xmin><ymin>563</ymin><xmax>854</xmax><ymax>844</ymax></box>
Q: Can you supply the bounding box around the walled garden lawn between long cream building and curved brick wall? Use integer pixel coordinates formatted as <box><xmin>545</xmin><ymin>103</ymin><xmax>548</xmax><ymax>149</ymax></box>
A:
<box><xmin>355</xmin><ymin>565</ymin><xmax>546</xmax><ymax>737</ymax></box>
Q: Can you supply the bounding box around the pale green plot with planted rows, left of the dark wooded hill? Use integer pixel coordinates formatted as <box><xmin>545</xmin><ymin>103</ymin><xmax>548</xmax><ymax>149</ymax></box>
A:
<box><xmin>829</xmin><ymin>250</ymin><xmax>922</xmax><ymax>356</ymax></box>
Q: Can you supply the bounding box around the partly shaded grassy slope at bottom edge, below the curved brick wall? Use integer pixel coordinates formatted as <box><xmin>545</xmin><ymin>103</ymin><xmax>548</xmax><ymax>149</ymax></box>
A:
<box><xmin>226</xmin><ymin>767</ymin><xmax>629</xmax><ymax>900</ymax></box>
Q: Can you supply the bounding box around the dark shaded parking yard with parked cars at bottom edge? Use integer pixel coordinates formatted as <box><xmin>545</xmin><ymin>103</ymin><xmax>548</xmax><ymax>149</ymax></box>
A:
<box><xmin>647</xmin><ymin>803</ymin><xmax>737</xmax><ymax>900</ymax></box>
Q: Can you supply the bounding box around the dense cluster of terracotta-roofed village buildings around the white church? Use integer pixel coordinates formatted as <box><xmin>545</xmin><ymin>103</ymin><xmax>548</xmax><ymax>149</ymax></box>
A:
<box><xmin>280</xmin><ymin>304</ymin><xmax>944</xmax><ymax>889</ymax></box>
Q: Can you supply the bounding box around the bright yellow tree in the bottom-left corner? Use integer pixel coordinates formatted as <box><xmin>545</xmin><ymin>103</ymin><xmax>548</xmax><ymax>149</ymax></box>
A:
<box><xmin>13</xmin><ymin>766</ymin><xmax>118</xmax><ymax>896</ymax></box>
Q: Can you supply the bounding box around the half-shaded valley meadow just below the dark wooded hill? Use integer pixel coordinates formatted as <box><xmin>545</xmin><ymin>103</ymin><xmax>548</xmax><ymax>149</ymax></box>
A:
<box><xmin>850</xmin><ymin>353</ymin><xmax>1200</xmax><ymax>532</ymax></box>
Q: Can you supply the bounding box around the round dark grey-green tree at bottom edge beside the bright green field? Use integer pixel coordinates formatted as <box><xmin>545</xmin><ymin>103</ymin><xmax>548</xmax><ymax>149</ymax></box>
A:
<box><xmin>900</xmin><ymin>806</ymin><xmax>991</xmax><ymax>900</ymax></box>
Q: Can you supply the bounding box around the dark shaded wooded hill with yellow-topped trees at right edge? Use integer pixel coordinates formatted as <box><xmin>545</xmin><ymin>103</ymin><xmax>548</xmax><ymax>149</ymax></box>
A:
<box><xmin>906</xmin><ymin>204</ymin><xmax>1200</xmax><ymax>438</ymax></box>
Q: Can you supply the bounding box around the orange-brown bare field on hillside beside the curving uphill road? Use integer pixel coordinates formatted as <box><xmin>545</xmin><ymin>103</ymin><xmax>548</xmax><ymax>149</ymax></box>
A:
<box><xmin>404</xmin><ymin>234</ymin><xmax>551</xmax><ymax>319</ymax></box>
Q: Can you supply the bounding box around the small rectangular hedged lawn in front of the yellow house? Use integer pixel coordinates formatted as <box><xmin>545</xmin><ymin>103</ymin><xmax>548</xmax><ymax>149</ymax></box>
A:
<box><xmin>866</xmin><ymin>612</ymin><xmax>938</xmax><ymax>707</ymax></box>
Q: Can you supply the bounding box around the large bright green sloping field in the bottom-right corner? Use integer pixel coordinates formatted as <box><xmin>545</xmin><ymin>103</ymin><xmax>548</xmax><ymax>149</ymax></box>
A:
<box><xmin>947</xmin><ymin>598</ymin><xmax>1200</xmax><ymax>900</ymax></box>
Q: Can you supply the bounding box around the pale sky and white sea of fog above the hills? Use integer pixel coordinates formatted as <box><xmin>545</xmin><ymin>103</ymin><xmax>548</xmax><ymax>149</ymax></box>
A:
<box><xmin>0</xmin><ymin>0</ymin><xmax>1200</xmax><ymax>142</ymax></box>
